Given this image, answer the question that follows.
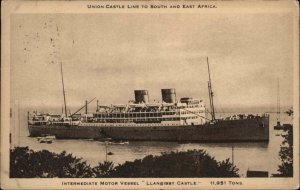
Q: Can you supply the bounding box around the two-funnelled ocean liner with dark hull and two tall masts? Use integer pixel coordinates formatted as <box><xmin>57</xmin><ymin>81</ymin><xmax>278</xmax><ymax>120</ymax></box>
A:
<box><xmin>28</xmin><ymin>59</ymin><xmax>269</xmax><ymax>142</ymax></box>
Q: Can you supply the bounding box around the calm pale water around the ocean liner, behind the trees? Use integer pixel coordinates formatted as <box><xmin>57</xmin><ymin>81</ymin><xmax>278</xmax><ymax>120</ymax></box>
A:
<box><xmin>11</xmin><ymin>109</ymin><xmax>292</xmax><ymax>177</ymax></box>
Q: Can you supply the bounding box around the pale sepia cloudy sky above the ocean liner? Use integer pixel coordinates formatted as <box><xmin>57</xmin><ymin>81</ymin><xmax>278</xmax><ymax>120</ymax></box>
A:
<box><xmin>11</xmin><ymin>13</ymin><xmax>293</xmax><ymax>112</ymax></box>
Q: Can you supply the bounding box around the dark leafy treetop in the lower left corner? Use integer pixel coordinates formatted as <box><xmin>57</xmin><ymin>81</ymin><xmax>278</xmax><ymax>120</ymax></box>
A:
<box><xmin>10</xmin><ymin>147</ymin><xmax>93</xmax><ymax>178</ymax></box>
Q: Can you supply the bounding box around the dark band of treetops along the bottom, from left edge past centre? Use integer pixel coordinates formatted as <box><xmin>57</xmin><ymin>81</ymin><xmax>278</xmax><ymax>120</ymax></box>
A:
<box><xmin>10</xmin><ymin>147</ymin><xmax>239</xmax><ymax>178</ymax></box>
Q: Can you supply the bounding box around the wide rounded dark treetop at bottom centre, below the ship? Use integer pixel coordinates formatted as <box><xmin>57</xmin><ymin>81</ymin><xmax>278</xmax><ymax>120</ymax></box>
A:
<box><xmin>106</xmin><ymin>150</ymin><xmax>239</xmax><ymax>178</ymax></box>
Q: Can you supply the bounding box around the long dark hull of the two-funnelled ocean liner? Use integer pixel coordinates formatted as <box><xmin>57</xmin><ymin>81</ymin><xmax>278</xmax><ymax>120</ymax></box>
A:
<box><xmin>28</xmin><ymin>117</ymin><xmax>269</xmax><ymax>142</ymax></box>
